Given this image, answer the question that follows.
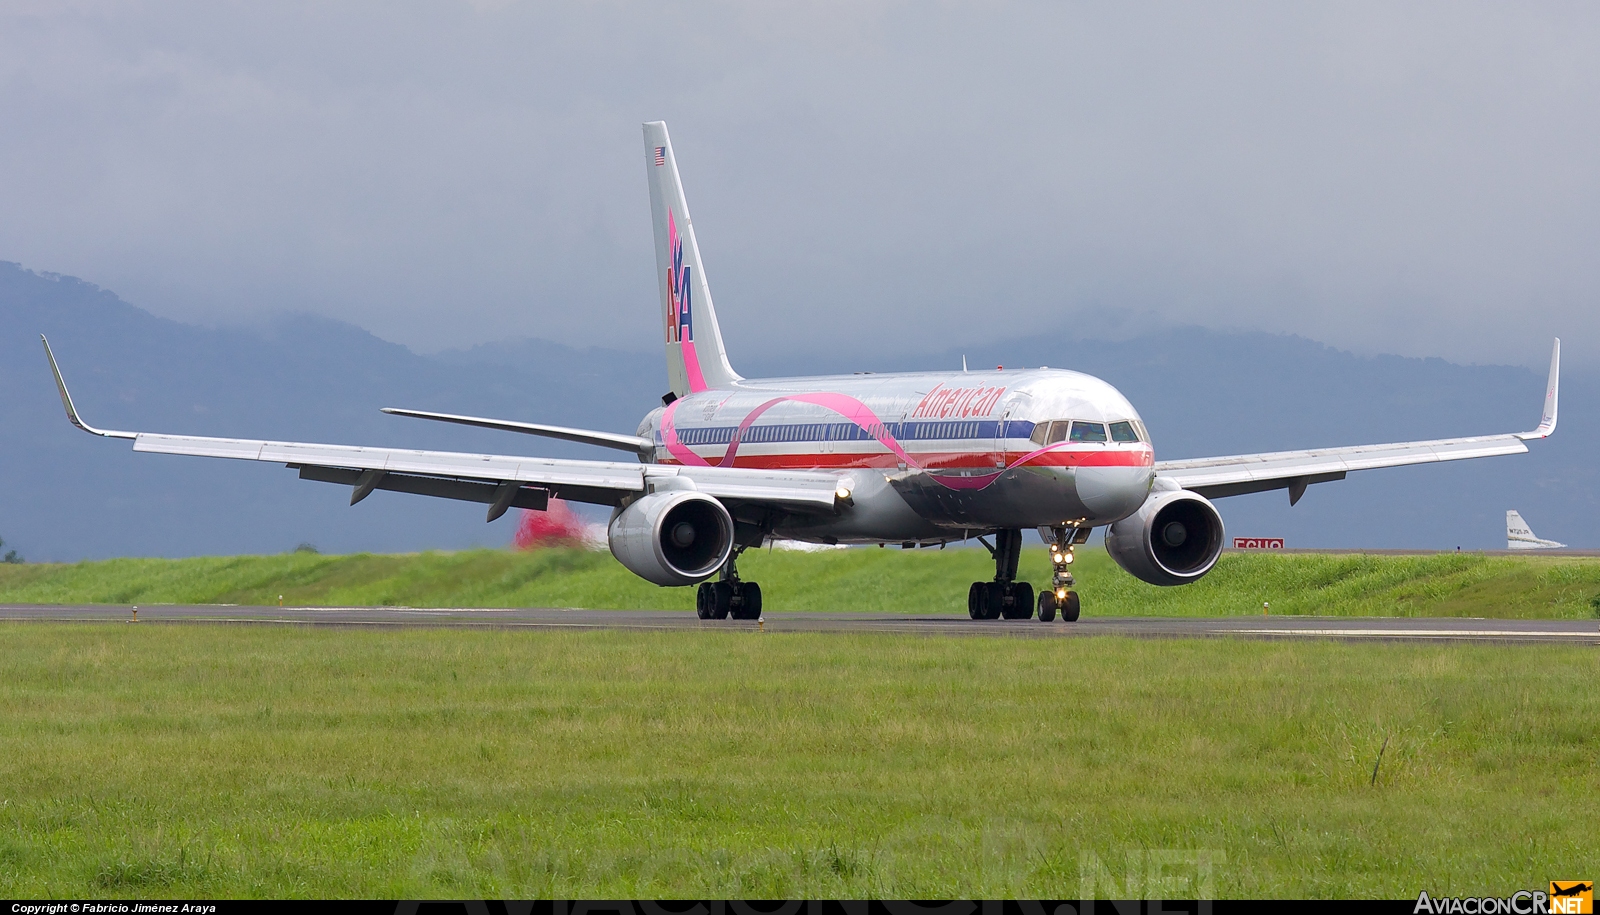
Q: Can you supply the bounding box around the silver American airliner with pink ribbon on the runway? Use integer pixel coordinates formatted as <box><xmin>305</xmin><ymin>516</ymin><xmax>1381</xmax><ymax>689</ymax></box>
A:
<box><xmin>42</xmin><ymin>122</ymin><xmax>1562</xmax><ymax>622</ymax></box>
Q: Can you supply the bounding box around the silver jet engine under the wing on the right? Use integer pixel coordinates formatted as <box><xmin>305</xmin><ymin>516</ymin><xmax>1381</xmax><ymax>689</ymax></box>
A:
<box><xmin>1106</xmin><ymin>489</ymin><xmax>1224</xmax><ymax>585</ymax></box>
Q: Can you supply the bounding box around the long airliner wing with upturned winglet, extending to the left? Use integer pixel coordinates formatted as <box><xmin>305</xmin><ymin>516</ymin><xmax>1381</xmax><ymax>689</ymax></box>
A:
<box><xmin>40</xmin><ymin>338</ymin><xmax>838</xmax><ymax>521</ymax></box>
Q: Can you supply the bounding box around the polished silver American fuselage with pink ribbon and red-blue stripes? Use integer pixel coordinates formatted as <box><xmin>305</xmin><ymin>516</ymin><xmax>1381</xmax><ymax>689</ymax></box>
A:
<box><xmin>638</xmin><ymin>368</ymin><xmax>1154</xmax><ymax>542</ymax></box>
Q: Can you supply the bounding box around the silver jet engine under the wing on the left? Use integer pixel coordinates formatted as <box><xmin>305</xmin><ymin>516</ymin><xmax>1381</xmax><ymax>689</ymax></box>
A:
<box><xmin>606</xmin><ymin>489</ymin><xmax>733</xmax><ymax>585</ymax></box>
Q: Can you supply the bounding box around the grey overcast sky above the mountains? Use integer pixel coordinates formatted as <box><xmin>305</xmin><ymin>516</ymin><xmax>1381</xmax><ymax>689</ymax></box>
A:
<box><xmin>0</xmin><ymin>0</ymin><xmax>1600</xmax><ymax>366</ymax></box>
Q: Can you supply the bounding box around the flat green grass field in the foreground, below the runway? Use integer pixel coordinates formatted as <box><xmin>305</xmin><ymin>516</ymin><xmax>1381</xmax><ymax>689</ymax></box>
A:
<box><xmin>0</xmin><ymin>624</ymin><xmax>1600</xmax><ymax>897</ymax></box>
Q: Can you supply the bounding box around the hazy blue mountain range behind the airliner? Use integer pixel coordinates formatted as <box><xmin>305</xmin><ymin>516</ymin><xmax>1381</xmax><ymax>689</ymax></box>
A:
<box><xmin>0</xmin><ymin>262</ymin><xmax>1600</xmax><ymax>561</ymax></box>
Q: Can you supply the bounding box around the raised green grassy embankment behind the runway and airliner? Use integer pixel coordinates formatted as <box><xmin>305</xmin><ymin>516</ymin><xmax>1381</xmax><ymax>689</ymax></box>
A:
<box><xmin>0</xmin><ymin>549</ymin><xmax>1600</xmax><ymax>619</ymax></box>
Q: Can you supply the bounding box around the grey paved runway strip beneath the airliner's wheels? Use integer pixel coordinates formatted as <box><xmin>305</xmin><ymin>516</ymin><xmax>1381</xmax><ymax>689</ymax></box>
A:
<box><xmin>0</xmin><ymin>605</ymin><xmax>1600</xmax><ymax>645</ymax></box>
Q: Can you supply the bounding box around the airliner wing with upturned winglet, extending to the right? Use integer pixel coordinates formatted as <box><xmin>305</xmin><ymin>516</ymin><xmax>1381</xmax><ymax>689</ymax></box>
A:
<box><xmin>1155</xmin><ymin>338</ymin><xmax>1562</xmax><ymax>505</ymax></box>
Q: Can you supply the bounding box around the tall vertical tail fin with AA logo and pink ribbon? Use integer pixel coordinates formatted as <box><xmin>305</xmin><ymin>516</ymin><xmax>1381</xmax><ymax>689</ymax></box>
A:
<box><xmin>645</xmin><ymin>120</ymin><xmax>739</xmax><ymax>397</ymax></box>
